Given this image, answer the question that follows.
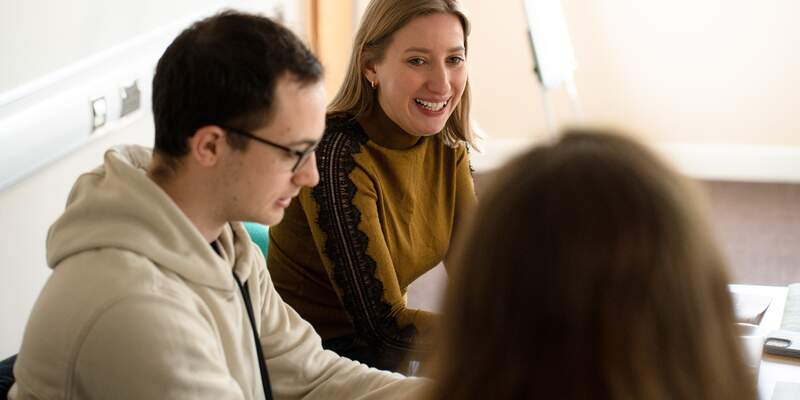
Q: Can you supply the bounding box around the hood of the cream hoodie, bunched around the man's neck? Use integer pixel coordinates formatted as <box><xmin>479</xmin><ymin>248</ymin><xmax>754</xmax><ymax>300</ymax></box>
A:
<box><xmin>47</xmin><ymin>146</ymin><xmax>256</xmax><ymax>290</ymax></box>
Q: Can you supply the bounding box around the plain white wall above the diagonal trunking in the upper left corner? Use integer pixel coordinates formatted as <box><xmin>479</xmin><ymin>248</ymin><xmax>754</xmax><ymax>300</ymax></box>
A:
<box><xmin>0</xmin><ymin>0</ymin><xmax>219</xmax><ymax>93</ymax></box>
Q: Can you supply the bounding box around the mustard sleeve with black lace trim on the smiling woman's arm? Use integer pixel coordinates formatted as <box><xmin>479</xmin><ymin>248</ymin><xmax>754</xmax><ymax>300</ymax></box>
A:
<box><xmin>300</xmin><ymin>122</ymin><xmax>436</xmax><ymax>358</ymax></box>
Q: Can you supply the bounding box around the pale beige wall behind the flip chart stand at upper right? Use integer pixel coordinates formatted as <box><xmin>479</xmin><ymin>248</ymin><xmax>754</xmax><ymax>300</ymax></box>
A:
<box><xmin>462</xmin><ymin>0</ymin><xmax>800</xmax><ymax>146</ymax></box>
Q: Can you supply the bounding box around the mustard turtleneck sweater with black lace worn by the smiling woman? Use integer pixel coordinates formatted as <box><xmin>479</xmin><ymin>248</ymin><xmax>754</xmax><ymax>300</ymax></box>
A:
<box><xmin>267</xmin><ymin>112</ymin><xmax>475</xmax><ymax>368</ymax></box>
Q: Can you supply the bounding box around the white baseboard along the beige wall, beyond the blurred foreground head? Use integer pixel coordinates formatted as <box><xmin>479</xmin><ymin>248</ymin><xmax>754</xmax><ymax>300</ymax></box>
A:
<box><xmin>470</xmin><ymin>138</ymin><xmax>800</xmax><ymax>183</ymax></box>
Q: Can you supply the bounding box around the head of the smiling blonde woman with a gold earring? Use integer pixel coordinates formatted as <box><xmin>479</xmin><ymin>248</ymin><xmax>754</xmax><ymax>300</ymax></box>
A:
<box><xmin>328</xmin><ymin>0</ymin><xmax>473</xmax><ymax>145</ymax></box>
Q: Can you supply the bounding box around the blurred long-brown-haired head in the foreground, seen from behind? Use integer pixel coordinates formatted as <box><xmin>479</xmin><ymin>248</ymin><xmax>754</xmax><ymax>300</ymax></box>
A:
<box><xmin>438</xmin><ymin>131</ymin><xmax>755</xmax><ymax>400</ymax></box>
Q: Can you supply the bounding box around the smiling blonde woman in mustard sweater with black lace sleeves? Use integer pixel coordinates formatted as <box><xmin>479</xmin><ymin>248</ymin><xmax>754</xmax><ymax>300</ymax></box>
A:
<box><xmin>268</xmin><ymin>0</ymin><xmax>475</xmax><ymax>372</ymax></box>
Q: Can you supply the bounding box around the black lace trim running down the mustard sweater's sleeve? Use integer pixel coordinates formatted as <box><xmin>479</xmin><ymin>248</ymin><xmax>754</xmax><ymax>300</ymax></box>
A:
<box><xmin>311</xmin><ymin>118</ymin><xmax>417</xmax><ymax>358</ymax></box>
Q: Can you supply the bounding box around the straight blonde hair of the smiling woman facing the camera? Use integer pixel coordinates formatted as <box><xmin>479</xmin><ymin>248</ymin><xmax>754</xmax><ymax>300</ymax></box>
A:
<box><xmin>328</xmin><ymin>0</ymin><xmax>475</xmax><ymax>146</ymax></box>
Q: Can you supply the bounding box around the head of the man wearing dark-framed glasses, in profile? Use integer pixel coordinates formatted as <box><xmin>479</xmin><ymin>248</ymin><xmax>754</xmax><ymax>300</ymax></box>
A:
<box><xmin>151</xmin><ymin>11</ymin><xmax>325</xmax><ymax>225</ymax></box>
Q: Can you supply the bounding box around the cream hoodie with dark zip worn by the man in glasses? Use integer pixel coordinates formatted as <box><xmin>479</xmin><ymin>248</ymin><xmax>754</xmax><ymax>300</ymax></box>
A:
<box><xmin>9</xmin><ymin>146</ymin><xmax>427</xmax><ymax>399</ymax></box>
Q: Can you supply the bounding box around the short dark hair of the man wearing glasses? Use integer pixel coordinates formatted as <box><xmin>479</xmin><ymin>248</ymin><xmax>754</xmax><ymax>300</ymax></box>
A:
<box><xmin>153</xmin><ymin>11</ymin><xmax>322</xmax><ymax>164</ymax></box>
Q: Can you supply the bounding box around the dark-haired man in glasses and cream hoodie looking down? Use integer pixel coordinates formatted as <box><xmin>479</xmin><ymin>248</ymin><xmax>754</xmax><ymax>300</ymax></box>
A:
<box><xmin>10</xmin><ymin>12</ymin><xmax>432</xmax><ymax>399</ymax></box>
